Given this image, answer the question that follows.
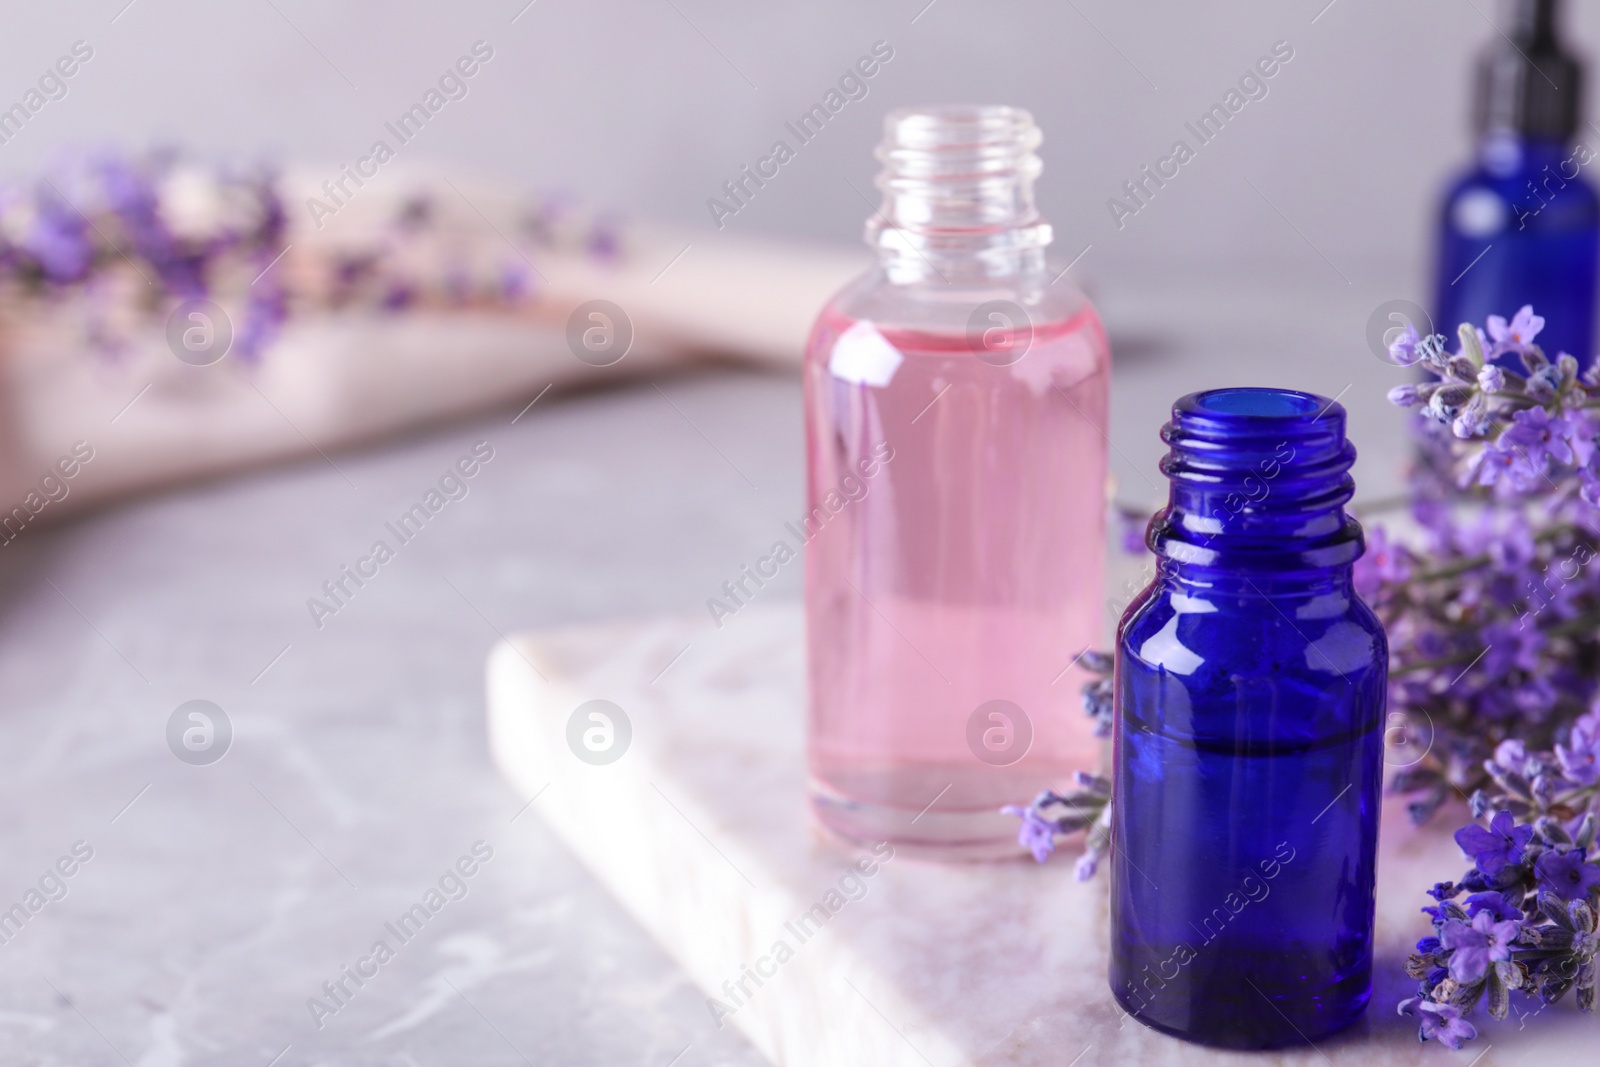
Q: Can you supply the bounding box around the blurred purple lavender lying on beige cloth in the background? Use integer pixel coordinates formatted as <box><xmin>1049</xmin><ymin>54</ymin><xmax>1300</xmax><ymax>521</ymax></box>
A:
<box><xmin>0</xmin><ymin>150</ymin><xmax>626</xmax><ymax>365</ymax></box>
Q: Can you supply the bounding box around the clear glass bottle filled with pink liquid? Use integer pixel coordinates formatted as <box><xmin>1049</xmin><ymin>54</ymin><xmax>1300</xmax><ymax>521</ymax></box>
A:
<box><xmin>803</xmin><ymin>107</ymin><xmax>1109</xmax><ymax>859</ymax></box>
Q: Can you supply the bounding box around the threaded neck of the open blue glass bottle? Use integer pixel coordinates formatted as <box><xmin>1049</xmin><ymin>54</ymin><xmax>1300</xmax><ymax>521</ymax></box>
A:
<box><xmin>1147</xmin><ymin>389</ymin><xmax>1362</xmax><ymax>573</ymax></box>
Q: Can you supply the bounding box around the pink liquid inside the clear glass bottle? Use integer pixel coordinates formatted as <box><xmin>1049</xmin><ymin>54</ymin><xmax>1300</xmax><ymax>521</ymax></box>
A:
<box><xmin>806</xmin><ymin>300</ymin><xmax>1107</xmax><ymax>857</ymax></box>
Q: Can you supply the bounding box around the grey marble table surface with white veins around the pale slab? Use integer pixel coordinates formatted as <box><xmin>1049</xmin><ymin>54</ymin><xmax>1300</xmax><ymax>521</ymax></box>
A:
<box><xmin>0</xmin><ymin>286</ymin><xmax>1400</xmax><ymax>1067</ymax></box>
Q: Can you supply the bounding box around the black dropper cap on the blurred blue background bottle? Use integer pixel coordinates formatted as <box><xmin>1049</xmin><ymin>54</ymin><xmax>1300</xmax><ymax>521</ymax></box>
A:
<box><xmin>1477</xmin><ymin>0</ymin><xmax>1584</xmax><ymax>141</ymax></box>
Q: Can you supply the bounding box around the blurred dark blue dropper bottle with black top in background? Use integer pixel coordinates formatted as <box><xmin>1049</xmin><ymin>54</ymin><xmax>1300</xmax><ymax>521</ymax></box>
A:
<box><xmin>1434</xmin><ymin>0</ymin><xmax>1600</xmax><ymax>366</ymax></box>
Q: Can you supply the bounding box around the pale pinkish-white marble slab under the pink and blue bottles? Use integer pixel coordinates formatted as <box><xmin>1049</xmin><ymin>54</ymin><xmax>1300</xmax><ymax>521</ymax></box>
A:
<box><xmin>488</xmin><ymin>603</ymin><xmax>1594</xmax><ymax>1067</ymax></box>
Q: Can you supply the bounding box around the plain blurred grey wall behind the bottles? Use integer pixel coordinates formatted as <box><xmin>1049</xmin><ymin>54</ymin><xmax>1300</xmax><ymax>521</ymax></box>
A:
<box><xmin>0</xmin><ymin>0</ymin><xmax>1548</xmax><ymax>287</ymax></box>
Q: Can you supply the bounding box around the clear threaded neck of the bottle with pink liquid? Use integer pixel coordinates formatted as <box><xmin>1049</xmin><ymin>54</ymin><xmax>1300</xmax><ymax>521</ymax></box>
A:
<box><xmin>867</xmin><ymin>106</ymin><xmax>1051</xmax><ymax>282</ymax></box>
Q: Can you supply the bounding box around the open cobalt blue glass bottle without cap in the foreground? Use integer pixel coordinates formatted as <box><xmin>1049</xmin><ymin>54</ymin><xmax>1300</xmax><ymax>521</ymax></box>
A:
<box><xmin>1110</xmin><ymin>389</ymin><xmax>1389</xmax><ymax>1048</ymax></box>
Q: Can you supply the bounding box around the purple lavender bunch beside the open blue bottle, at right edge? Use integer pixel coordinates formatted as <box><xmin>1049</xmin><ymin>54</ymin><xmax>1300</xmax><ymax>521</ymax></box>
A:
<box><xmin>1363</xmin><ymin>307</ymin><xmax>1600</xmax><ymax>1048</ymax></box>
